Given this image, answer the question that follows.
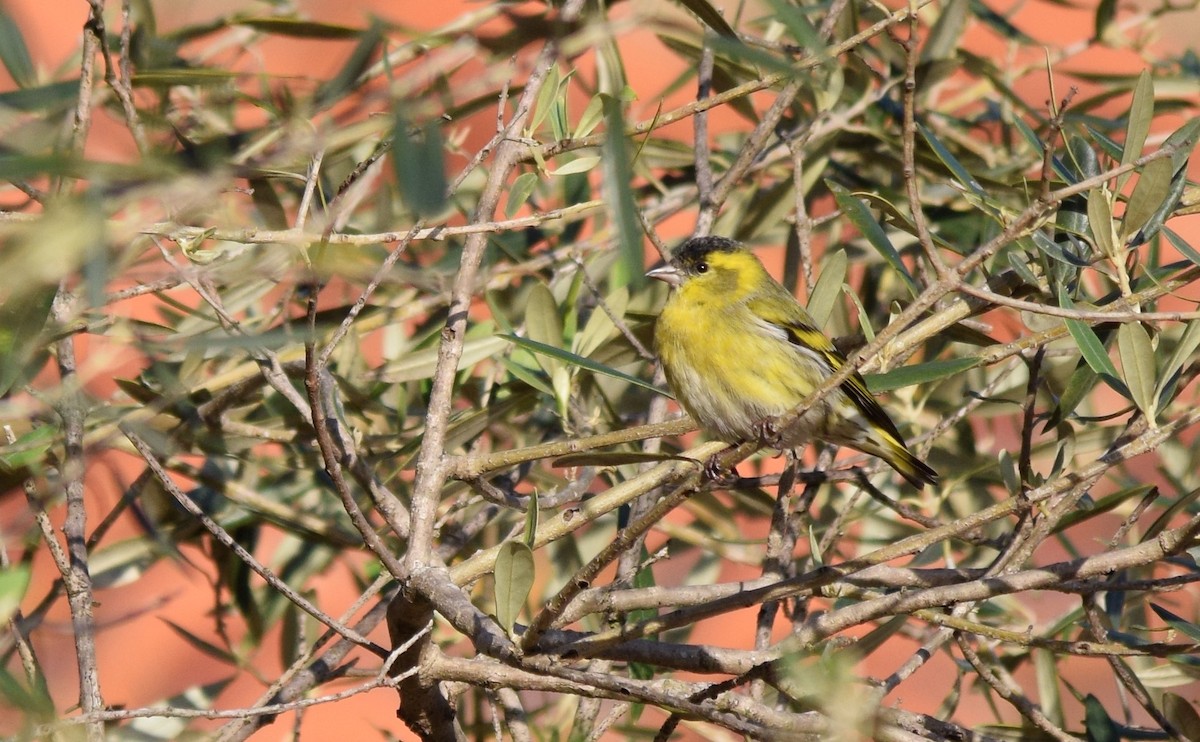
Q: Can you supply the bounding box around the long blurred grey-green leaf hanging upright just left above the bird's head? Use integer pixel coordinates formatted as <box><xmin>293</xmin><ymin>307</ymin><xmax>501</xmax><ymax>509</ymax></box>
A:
<box><xmin>601</xmin><ymin>95</ymin><xmax>644</xmax><ymax>288</ymax></box>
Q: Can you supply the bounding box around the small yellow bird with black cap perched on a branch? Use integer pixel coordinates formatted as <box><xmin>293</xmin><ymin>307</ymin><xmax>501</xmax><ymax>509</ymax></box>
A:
<box><xmin>646</xmin><ymin>237</ymin><xmax>937</xmax><ymax>489</ymax></box>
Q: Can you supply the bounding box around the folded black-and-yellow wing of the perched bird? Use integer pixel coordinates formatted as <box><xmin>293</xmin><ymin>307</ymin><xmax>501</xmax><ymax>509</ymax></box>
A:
<box><xmin>748</xmin><ymin>287</ymin><xmax>904</xmax><ymax>439</ymax></box>
